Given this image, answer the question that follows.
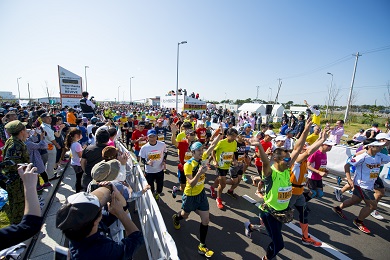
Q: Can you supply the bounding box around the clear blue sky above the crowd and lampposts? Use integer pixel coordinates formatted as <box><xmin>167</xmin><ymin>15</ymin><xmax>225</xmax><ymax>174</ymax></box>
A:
<box><xmin>0</xmin><ymin>0</ymin><xmax>390</xmax><ymax>105</ymax></box>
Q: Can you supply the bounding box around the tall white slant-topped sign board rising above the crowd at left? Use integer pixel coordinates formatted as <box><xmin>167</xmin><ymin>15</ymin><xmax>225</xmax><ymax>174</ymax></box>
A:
<box><xmin>58</xmin><ymin>65</ymin><xmax>83</xmax><ymax>107</ymax></box>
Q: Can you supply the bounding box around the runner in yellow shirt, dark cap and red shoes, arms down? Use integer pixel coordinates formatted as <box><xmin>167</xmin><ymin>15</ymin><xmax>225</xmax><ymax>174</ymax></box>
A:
<box><xmin>210</xmin><ymin>128</ymin><xmax>238</xmax><ymax>209</ymax></box>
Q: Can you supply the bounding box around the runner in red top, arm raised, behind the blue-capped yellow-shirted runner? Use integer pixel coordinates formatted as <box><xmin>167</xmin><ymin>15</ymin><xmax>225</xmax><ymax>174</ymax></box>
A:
<box><xmin>171</xmin><ymin>124</ymin><xmax>195</xmax><ymax>198</ymax></box>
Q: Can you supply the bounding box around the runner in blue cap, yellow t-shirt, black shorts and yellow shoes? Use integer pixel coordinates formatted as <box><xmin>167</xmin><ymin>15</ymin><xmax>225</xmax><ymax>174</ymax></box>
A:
<box><xmin>172</xmin><ymin>137</ymin><xmax>219</xmax><ymax>258</ymax></box>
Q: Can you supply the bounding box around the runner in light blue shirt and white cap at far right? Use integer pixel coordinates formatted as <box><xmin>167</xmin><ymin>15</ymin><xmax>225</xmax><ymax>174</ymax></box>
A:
<box><xmin>333</xmin><ymin>139</ymin><xmax>390</xmax><ymax>234</ymax></box>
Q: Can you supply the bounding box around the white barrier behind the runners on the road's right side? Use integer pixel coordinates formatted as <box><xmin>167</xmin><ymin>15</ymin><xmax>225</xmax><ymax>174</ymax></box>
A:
<box><xmin>327</xmin><ymin>145</ymin><xmax>390</xmax><ymax>189</ymax></box>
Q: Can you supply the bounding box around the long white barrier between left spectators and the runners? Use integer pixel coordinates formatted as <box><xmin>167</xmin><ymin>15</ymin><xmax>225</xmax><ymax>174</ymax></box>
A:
<box><xmin>116</xmin><ymin>142</ymin><xmax>179</xmax><ymax>260</ymax></box>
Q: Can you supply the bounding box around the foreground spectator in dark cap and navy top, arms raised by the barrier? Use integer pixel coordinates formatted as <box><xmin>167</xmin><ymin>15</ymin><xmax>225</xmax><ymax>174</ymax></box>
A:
<box><xmin>56</xmin><ymin>185</ymin><xmax>144</xmax><ymax>259</ymax></box>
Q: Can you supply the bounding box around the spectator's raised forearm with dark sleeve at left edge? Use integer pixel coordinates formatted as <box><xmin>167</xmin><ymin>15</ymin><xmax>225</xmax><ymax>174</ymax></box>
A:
<box><xmin>0</xmin><ymin>163</ymin><xmax>43</xmax><ymax>250</ymax></box>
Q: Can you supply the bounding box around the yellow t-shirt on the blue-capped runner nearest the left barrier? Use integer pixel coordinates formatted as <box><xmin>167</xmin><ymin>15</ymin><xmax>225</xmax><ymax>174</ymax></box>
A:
<box><xmin>184</xmin><ymin>152</ymin><xmax>208</xmax><ymax>196</ymax></box>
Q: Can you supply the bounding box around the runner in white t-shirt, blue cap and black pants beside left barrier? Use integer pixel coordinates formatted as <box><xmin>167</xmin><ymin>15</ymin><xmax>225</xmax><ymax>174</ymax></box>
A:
<box><xmin>139</xmin><ymin>129</ymin><xmax>167</xmax><ymax>201</ymax></box>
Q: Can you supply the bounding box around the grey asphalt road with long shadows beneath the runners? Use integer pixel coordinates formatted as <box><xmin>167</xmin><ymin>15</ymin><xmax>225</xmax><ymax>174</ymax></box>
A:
<box><xmin>152</xmin><ymin>141</ymin><xmax>390</xmax><ymax>259</ymax></box>
